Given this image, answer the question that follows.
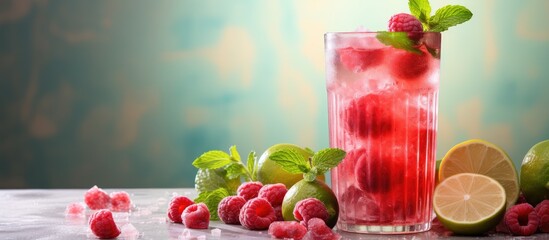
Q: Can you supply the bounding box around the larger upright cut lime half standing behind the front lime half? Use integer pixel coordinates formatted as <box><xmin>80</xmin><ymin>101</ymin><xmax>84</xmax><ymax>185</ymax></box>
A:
<box><xmin>438</xmin><ymin>139</ymin><xmax>519</xmax><ymax>208</ymax></box>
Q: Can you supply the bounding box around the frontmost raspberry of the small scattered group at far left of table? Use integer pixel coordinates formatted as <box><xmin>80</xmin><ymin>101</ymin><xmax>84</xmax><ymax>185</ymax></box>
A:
<box><xmin>89</xmin><ymin>209</ymin><xmax>120</xmax><ymax>238</ymax></box>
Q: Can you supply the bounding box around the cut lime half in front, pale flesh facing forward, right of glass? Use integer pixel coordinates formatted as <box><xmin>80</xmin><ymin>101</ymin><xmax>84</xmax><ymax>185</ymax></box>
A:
<box><xmin>433</xmin><ymin>173</ymin><xmax>507</xmax><ymax>235</ymax></box>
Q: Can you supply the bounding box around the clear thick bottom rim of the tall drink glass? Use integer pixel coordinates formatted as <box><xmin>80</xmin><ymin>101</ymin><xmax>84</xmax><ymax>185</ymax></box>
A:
<box><xmin>337</xmin><ymin>222</ymin><xmax>431</xmax><ymax>234</ymax></box>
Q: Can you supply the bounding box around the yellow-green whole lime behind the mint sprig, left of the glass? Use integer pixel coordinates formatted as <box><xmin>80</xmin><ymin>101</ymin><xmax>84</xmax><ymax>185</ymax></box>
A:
<box><xmin>257</xmin><ymin>143</ymin><xmax>324</xmax><ymax>188</ymax></box>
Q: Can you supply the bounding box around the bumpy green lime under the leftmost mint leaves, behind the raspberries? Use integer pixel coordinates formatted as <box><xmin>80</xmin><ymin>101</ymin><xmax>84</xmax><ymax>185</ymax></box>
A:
<box><xmin>194</xmin><ymin>168</ymin><xmax>240</xmax><ymax>194</ymax></box>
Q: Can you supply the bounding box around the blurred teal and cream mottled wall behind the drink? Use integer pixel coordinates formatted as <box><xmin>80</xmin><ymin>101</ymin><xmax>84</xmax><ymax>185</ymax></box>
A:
<box><xmin>0</xmin><ymin>0</ymin><xmax>549</xmax><ymax>188</ymax></box>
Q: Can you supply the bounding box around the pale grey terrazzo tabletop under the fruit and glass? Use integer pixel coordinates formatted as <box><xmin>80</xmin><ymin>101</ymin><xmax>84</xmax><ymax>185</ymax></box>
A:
<box><xmin>0</xmin><ymin>188</ymin><xmax>549</xmax><ymax>240</ymax></box>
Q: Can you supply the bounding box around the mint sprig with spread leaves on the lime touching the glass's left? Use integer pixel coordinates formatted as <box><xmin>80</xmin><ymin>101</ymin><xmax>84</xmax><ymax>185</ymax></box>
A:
<box><xmin>269</xmin><ymin>148</ymin><xmax>346</xmax><ymax>182</ymax></box>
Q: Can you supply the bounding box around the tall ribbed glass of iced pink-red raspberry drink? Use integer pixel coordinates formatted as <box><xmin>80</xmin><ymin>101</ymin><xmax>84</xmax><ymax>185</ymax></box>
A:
<box><xmin>325</xmin><ymin>32</ymin><xmax>440</xmax><ymax>233</ymax></box>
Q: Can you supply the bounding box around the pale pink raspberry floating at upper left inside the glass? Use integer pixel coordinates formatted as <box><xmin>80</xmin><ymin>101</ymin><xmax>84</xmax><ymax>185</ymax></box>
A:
<box><xmin>337</xmin><ymin>47</ymin><xmax>384</xmax><ymax>72</ymax></box>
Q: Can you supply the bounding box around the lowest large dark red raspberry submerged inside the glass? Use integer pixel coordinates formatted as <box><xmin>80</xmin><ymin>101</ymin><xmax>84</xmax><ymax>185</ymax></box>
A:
<box><xmin>345</xmin><ymin>146</ymin><xmax>406</xmax><ymax>193</ymax></box>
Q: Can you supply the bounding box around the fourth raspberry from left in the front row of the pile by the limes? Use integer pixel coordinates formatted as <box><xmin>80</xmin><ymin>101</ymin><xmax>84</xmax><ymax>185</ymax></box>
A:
<box><xmin>239</xmin><ymin>198</ymin><xmax>276</xmax><ymax>230</ymax></box>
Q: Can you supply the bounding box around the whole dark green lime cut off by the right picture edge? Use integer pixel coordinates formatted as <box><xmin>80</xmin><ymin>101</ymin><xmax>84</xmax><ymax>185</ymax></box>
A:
<box><xmin>520</xmin><ymin>140</ymin><xmax>549</xmax><ymax>206</ymax></box>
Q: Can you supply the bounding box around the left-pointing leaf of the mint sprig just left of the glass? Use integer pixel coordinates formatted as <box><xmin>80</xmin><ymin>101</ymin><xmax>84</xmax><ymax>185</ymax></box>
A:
<box><xmin>269</xmin><ymin>149</ymin><xmax>310</xmax><ymax>173</ymax></box>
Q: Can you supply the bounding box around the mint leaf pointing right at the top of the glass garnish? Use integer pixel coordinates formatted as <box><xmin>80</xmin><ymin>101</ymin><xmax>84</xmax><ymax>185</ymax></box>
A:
<box><xmin>429</xmin><ymin>5</ymin><xmax>473</xmax><ymax>32</ymax></box>
